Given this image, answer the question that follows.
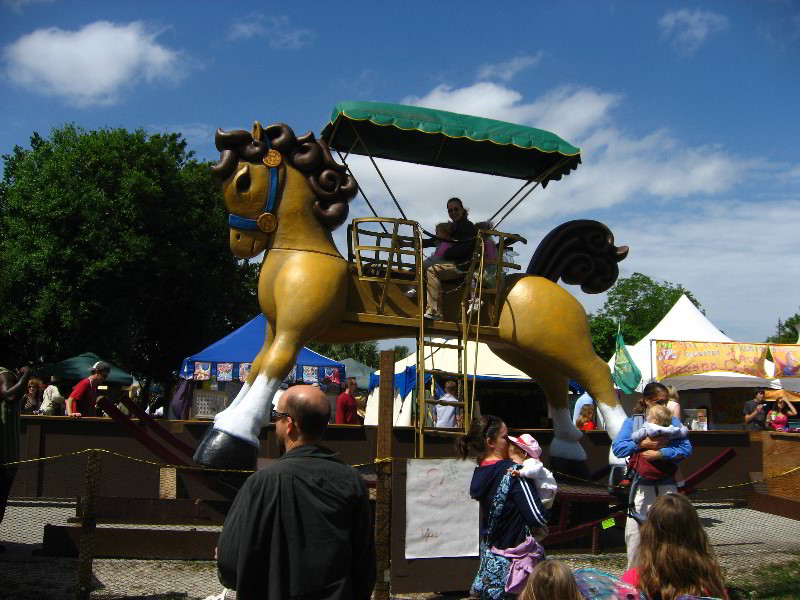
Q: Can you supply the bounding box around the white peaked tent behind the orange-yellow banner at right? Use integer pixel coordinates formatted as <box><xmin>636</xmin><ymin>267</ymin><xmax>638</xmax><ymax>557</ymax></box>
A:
<box><xmin>608</xmin><ymin>295</ymin><xmax>800</xmax><ymax>391</ymax></box>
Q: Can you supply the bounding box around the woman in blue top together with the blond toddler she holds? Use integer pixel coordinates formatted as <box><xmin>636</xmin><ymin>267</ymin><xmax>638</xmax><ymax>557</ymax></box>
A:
<box><xmin>611</xmin><ymin>382</ymin><xmax>692</xmax><ymax>568</ymax></box>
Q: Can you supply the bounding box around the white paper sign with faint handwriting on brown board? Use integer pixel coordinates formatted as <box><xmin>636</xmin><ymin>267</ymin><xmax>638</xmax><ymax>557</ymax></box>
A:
<box><xmin>406</xmin><ymin>458</ymin><xmax>479</xmax><ymax>558</ymax></box>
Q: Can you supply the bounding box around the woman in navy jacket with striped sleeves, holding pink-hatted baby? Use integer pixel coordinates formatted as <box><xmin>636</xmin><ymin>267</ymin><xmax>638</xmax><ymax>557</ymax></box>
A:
<box><xmin>456</xmin><ymin>415</ymin><xmax>549</xmax><ymax>600</ymax></box>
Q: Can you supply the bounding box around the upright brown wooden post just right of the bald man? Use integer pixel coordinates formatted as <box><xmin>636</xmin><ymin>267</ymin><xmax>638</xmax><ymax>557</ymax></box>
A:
<box><xmin>373</xmin><ymin>350</ymin><xmax>394</xmax><ymax>600</ymax></box>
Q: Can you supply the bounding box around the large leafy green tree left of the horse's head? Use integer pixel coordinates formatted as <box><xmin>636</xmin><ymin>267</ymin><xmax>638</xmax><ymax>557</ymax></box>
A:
<box><xmin>0</xmin><ymin>125</ymin><xmax>258</xmax><ymax>394</ymax></box>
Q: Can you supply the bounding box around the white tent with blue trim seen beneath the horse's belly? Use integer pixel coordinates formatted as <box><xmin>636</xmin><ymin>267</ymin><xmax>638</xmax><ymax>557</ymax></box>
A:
<box><xmin>364</xmin><ymin>338</ymin><xmax>530</xmax><ymax>426</ymax></box>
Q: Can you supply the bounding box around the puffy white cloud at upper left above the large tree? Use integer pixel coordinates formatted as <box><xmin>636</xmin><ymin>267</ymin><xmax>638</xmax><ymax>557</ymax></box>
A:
<box><xmin>3</xmin><ymin>21</ymin><xmax>185</xmax><ymax>106</ymax></box>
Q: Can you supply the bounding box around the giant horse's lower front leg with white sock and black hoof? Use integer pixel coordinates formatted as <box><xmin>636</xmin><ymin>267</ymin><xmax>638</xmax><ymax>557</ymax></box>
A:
<box><xmin>194</xmin><ymin>330</ymin><xmax>304</xmax><ymax>469</ymax></box>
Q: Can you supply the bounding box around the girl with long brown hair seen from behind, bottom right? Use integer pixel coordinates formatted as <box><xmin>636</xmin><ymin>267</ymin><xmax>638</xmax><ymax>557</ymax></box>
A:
<box><xmin>621</xmin><ymin>494</ymin><xmax>728</xmax><ymax>600</ymax></box>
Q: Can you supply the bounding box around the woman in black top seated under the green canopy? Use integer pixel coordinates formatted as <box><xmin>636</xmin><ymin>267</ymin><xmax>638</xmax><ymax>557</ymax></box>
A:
<box><xmin>424</xmin><ymin>198</ymin><xmax>478</xmax><ymax>319</ymax></box>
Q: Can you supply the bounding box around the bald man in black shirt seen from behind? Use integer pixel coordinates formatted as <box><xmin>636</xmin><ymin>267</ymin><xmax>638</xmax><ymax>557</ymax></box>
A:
<box><xmin>212</xmin><ymin>385</ymin><xmax>375</xmax><ymax>600</ymax></box>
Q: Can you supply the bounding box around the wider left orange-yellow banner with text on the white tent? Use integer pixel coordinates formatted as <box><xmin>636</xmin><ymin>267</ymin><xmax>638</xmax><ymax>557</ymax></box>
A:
<box><xmin>655</xmin><ymin>340</ymin><xmax>767</xmax><ymax>379</ymax></box>
